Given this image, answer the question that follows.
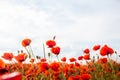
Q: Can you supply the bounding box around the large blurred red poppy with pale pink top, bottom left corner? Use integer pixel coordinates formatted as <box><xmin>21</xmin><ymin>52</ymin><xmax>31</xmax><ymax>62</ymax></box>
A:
<box><xmin>0</xmin><ymin>72</ymin><xmax>22</xmax><ymax>80</ymax></box>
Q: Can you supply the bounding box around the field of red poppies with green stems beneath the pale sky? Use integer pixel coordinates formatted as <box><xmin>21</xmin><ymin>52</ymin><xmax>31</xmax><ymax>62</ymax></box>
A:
<box><xmin>0</xmin><ymin>37</ymin><xmax>120</xmax><ymax>80</ymax></box>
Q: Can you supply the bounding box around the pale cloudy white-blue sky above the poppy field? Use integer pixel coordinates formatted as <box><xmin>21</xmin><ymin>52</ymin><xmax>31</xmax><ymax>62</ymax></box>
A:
<box><xmin>0</xmin><ymin>0</ymin><xmax>120</xmax><ymax>61</ymax></box>
